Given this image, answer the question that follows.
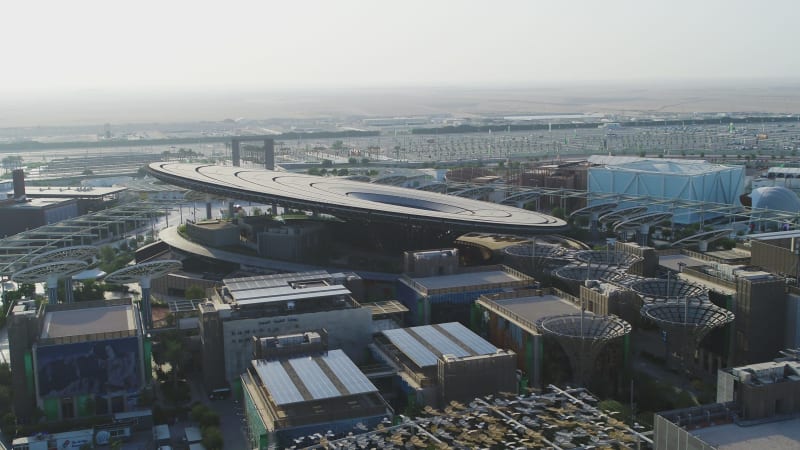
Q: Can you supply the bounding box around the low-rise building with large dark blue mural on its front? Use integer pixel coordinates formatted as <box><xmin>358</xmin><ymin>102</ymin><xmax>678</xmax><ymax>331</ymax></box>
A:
<box><xmin>9</xmin><ymin>299</ymin><xmax>151</xmax><ymax>423</ymax></box>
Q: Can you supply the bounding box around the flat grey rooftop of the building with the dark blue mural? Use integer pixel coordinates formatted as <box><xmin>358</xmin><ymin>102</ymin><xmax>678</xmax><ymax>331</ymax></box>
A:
<box><xmin>42</xmin><ymin>305</ymin><xmax>136</xmax><ymax>339</ymax></box>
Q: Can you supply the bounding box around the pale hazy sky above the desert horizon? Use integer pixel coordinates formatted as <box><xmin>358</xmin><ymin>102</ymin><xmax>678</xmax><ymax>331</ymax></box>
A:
<box><xmin>0</xmin><ymin>0</ymin><xmax>800</xmax><ymax>95</ymax></box>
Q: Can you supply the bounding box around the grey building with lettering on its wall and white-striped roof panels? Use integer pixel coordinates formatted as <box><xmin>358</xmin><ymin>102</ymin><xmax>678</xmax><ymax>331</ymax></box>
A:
<box><xmin>199</xmin><ymin>271</ymin><xmax>372</xmax><ymax>392</ymax></box>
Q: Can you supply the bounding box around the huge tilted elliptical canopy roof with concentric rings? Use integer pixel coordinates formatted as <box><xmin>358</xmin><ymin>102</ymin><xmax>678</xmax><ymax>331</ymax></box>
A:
<box><xmin>149</xmin><ymin>162</ymin><xmax>566</xmax><ymax>233</ymax></box>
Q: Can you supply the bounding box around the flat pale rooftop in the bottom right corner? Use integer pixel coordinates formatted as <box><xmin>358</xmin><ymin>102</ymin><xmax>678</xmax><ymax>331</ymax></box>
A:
<box><xmin>692</xmin><ymin>419</ymin><xmax>800</xmax><ymax>450</ymax></box>
